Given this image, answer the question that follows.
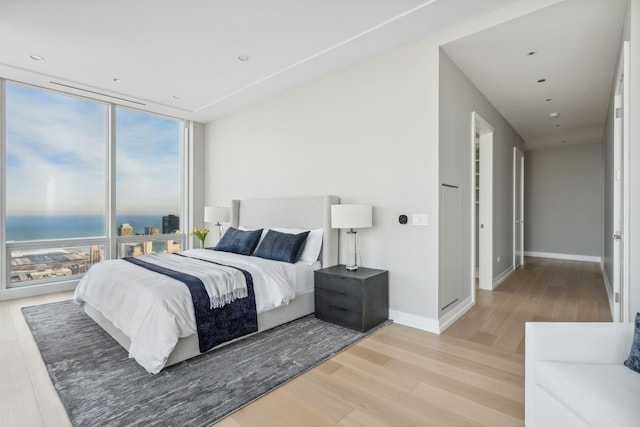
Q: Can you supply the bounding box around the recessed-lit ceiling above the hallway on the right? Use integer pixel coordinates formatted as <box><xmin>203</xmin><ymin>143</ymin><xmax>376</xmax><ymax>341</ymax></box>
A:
<box><xmin>443</xmin><ymin>0</ymin><xmax>627</xmax><ymax>150</ymax></box>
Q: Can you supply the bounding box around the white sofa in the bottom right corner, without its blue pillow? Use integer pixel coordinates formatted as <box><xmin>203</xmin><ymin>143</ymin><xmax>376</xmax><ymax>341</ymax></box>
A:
<box><xmin>525</xmin><ymin>322</ymin><xmax>640</xmax><ymax>427</ymax></box>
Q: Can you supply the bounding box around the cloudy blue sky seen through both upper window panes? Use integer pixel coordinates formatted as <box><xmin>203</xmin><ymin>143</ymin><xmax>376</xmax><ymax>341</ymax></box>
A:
<box><xmin>6</xmin><ymin>83</ymin><xmax>182</xmax><ymax>215</ymax></box>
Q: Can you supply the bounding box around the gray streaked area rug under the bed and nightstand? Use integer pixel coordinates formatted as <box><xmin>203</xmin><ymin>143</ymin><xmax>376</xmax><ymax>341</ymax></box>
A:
<box><xmin>22</xmin><ymin>301</ymin><xmax>389</xmax><ymax>426</ymax></box>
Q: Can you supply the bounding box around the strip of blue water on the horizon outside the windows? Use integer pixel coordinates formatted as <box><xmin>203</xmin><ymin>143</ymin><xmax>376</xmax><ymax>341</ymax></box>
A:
<box><xmin>7</xmin><ymin>214</ymin><xmax>178</xmax><ymax>242</ymax></box>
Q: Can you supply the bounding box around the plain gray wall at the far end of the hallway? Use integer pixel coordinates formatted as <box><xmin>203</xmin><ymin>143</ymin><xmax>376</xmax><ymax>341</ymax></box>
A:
<box><xmin>524</xmin><ymin>144</ymin><xmax>604</xmax><ymax>258</ymax></box>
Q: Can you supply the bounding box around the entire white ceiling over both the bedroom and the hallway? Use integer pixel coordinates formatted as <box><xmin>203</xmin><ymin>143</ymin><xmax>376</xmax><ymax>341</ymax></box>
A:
<box><xmin>0</xmin><ymin>0</ymin><xmax>626</xmax><ymax>151</ymax></box>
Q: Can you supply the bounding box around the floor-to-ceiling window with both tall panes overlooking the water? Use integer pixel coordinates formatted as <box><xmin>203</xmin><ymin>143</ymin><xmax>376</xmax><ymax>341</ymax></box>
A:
<box><xmin>0</xmin><ymin>82</ymin><xmax>185</xmax><ymax>288</ymax></box>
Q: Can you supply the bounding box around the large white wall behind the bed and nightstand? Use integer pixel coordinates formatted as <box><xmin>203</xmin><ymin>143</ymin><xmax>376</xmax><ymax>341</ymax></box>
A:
<box><xmin>206</xmin><ymin>37</ymin><xmax>438</xmax><ymax>329</ymax></box>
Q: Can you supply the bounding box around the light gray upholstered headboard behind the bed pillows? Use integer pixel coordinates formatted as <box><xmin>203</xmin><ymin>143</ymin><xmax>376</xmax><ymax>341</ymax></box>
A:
<box><xmin>231</xmin><ymin>196</ymin><xmax>340</xmax><ymax>267</ymax></box>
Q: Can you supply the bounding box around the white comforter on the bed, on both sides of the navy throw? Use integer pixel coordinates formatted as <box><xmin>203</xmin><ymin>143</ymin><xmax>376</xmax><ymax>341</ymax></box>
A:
<box><xmin>74</xmin><ymin>249</ymin><xmax>296</xmax><ymax>373</ymax></box>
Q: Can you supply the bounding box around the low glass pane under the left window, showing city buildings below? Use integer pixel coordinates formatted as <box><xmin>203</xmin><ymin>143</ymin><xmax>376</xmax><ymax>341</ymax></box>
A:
<box><xmin>8</xmin><ymin>245</ymin><xmax>104</xmax><ymax>287</ymax></box>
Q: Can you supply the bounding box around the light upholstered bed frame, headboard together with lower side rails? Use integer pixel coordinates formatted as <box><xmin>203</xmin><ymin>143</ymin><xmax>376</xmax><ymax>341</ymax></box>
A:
<box><xmin>84</xmin><ymin>196</ymin><xmax>340</xmax><ymax>367</ymax></box>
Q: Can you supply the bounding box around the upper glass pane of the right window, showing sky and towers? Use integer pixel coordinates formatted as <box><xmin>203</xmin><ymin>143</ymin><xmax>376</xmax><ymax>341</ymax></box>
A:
<box><xmin>116</xmin><ymin>107</ymin><xmax>182</xmax><ymax>236</ymax></box>
